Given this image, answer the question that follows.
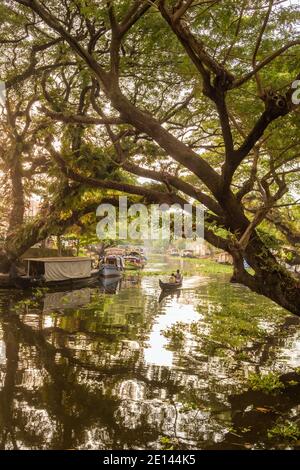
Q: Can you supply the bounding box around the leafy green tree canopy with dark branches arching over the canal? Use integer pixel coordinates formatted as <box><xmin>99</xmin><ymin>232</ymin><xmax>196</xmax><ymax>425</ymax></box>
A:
<box><xmin>0</xmin><ymin>0</ymin><xmax>300</xmax><ymax>314</ymax></box>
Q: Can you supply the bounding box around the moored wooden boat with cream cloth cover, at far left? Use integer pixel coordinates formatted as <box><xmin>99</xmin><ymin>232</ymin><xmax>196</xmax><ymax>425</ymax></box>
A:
<box><xmin>13</xmin><ymin>257</ymin><xmax>98</xmax><ymax>289</ymax></box>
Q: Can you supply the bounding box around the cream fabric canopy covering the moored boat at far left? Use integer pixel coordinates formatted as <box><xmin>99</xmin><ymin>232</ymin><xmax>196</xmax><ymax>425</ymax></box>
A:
<box><xmin>24</xmin><ymin>257</ymin><xmax>92</xmax><ymax>282</ymax></box>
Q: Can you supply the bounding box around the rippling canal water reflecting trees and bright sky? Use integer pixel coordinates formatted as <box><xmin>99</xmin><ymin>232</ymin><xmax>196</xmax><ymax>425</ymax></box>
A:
<box><xmin>0</xmin><ymin>258</ymin><xmax>300</xmax><ymax>450</ymax></box>
